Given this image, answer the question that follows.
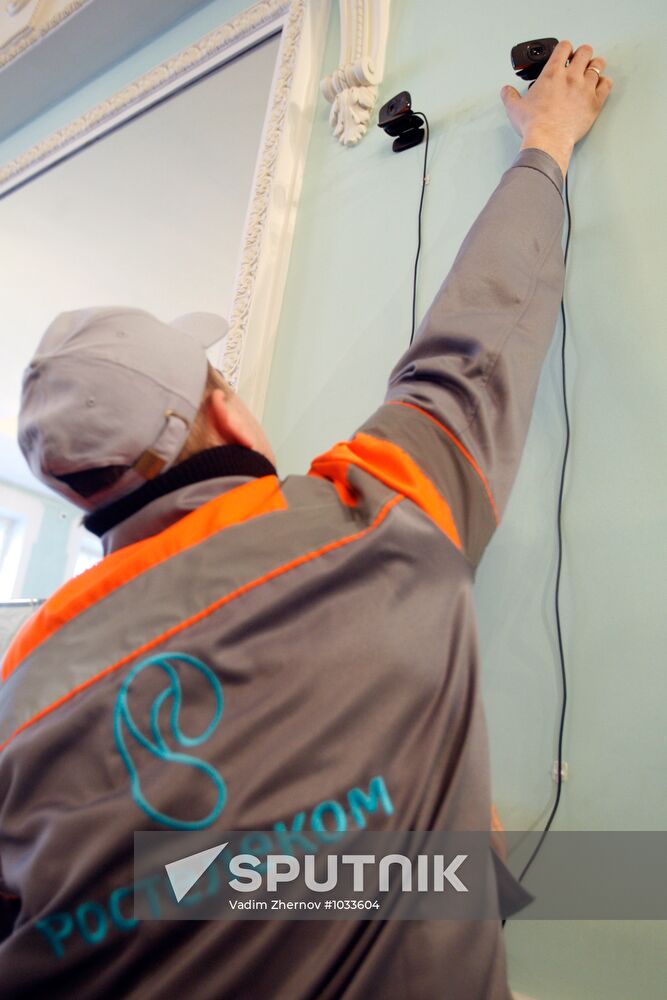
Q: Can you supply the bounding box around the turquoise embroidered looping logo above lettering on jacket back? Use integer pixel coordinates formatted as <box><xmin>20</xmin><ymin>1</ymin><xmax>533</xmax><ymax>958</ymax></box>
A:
<box><xmin>114</xmin><ymin>653</ymin><xmax>227</xmax><ymax>830</ymax></box>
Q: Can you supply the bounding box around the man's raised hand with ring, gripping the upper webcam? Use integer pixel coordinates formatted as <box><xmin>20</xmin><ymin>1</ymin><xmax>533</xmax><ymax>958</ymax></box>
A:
<box><xmin>500</xmin><ymin>42</ymin><xmax>613</xmax><ymax>176</ymax></box>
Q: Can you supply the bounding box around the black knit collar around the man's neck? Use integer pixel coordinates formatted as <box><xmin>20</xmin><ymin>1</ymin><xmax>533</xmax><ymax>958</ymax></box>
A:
<box><xmin>83</xmin><ymin>444</ymin><xmax>277</xmax><ymax>538</ymax></box>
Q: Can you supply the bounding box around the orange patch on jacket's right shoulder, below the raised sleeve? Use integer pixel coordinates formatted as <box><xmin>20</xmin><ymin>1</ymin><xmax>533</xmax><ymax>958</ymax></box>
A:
<box><xmin>308</xmin><ymin>431</ymin><xmax>461</xmax><ymax>549</ymax></box>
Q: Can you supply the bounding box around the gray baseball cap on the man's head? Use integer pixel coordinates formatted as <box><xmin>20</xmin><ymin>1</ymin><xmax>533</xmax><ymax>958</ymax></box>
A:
<box><xmin>18</xmin><ymin>306</ymin><xmax>228</xmax><ymax>511</ymax></box>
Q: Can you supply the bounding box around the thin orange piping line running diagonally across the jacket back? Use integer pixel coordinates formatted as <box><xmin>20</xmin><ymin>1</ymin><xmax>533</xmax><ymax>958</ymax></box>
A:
<box><xmin>0</xmin><ymin>492</ymin><xmax>403</xmax><ymax>751</ymax></box>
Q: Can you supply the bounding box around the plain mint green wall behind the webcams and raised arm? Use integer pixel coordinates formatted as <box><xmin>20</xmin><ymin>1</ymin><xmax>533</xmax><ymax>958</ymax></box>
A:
<box><xmin>264</xmin><ymin>0</ymin><xmax>667</xmax><ymax>1000</ymax></box>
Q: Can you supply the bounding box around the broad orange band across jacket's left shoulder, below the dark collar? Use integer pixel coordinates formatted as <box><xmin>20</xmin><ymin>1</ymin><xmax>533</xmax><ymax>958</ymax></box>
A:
<box><xmin>2</xmin><ymin>476</ymin><xmax>287</xmax><ymax>680</ymax></box>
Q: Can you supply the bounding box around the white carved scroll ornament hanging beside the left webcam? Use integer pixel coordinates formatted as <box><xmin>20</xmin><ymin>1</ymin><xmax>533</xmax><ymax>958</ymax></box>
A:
<box><xmin>320</xmin><ymin>0</ymin><xmax>390</xmax><ymax>146</ymax></box>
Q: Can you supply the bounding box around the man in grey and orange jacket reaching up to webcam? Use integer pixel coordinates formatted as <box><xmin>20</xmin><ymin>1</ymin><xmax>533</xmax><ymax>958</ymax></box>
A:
<box><xmin>0</xmin><ymin>42</ymin><xmax>611</xmax><ymax>1000</ymax></box>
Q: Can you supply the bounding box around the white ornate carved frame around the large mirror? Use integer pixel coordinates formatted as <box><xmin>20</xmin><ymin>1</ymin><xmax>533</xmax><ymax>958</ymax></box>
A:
<box><xmin>0</xmin><ymin>0</ymin><xmax>330</xmax><ymax>419</ymax></box>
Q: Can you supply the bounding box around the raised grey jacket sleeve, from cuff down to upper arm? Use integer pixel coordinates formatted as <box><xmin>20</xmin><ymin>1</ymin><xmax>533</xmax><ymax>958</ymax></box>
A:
<box><xmin>352</xmin><ymin>149</ymin><xmax>564</xmax><ymax>565</ymax></box>
